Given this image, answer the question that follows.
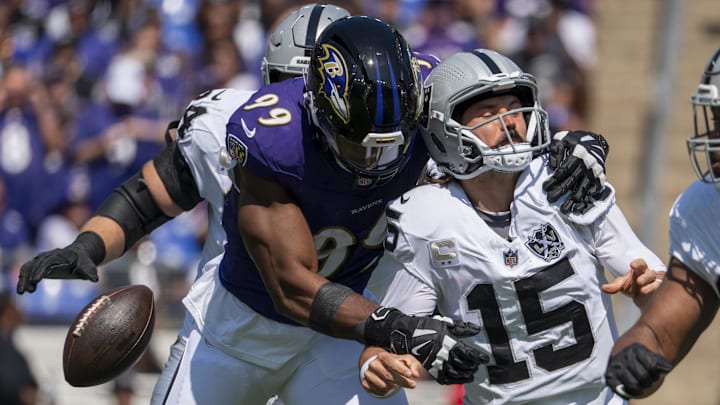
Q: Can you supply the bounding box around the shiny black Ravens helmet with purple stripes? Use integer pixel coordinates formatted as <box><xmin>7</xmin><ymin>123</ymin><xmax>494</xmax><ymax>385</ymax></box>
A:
<box><xmin>305</xmin><ymin>16</ymin><xmax>422</xmax><ymax>185</ymax></box>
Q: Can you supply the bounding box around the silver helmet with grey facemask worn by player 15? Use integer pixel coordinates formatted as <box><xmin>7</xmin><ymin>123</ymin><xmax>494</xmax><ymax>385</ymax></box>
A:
<box><xmin>420</xmin><ymin>49</ymin><xmax>550</xmax><ymax>179</ymax></box>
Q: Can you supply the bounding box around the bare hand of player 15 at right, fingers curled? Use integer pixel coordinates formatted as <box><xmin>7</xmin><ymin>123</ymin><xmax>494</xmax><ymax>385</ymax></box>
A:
<box><xmin>600</xmin><ymin>259</ymin><xmax>665</xmax><ymax>308</ymax></box>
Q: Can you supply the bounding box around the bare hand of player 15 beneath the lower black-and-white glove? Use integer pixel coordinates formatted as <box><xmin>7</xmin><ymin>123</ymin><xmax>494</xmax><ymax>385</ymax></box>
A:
<box><xmin>360</xmin><ymin>347</ymin><xmax>423</xmax><ymax>397</ymax></box>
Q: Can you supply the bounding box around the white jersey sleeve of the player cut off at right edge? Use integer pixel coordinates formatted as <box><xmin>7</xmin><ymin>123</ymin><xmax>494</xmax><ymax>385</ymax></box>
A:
<box><xmin>670</xmin><ymin>180</ymin><xmax>720</xmax><ymax>295</ymax></box>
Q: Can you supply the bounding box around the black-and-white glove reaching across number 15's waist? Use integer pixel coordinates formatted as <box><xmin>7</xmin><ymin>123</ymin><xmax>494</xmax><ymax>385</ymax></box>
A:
<box><xmin>365</xmin><ymin>307</ymin><xmax>490</xmax><ymax>384</ymax></box>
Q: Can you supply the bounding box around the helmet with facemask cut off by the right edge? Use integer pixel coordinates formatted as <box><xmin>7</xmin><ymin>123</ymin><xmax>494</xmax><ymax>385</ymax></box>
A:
<box><xmin>687</xmin><ymin>48</ymin><xmax>720</xmax><ymax>189</ymax></box>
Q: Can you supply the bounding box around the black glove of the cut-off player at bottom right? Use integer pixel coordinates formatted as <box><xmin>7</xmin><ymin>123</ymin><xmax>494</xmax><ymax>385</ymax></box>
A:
<box><xmin>605</xmin><ymin>343</ymin><xmax>672</xmax><ymax>399</ymax></box>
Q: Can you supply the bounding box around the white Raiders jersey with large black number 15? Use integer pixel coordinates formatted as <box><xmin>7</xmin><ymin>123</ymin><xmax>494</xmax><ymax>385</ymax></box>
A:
<box><xmin>382</xmin><ymin>158</ymin><xmax>665</xmax><ymax>404</ymax></box>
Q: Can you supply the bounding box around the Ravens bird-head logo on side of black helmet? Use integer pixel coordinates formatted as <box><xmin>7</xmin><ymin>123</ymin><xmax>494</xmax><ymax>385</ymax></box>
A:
<box><xmin>316</xmin><ymin>44</ymin><xmax>350</xmax><ymax>124</ymax></box>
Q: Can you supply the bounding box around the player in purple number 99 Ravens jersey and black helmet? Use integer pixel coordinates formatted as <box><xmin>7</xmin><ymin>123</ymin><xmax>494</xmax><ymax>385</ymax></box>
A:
<box><xmin>162</xmin><ymin>17</ymin><xmax>604</xmax><ymax>404</ymax></box>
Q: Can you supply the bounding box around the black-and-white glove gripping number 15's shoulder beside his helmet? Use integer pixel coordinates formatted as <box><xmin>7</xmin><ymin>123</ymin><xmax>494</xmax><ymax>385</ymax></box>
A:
<box><xmin>543</xmin><ymin>131</ymin><xmax>610</xmax><ymax>214</ymax></box>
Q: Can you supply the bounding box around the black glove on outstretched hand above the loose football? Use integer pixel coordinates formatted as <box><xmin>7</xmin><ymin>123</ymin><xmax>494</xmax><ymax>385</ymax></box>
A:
<box><xmin>17</xmin><ymin>232</ymin><xmax>105</xmax><ymax>294</ymax></box>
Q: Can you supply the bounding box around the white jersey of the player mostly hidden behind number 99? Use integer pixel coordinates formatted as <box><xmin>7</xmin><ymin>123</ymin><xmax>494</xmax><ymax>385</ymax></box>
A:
<box><xmin>177</xmin><ymin>88</ymin><xmax>253</xmax><ymax>271</ymax></box>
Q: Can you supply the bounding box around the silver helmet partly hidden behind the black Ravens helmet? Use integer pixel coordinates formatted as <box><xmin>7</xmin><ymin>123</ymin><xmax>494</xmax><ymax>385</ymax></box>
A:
<box><xmin>260</xmin><ymin>3</ymin><xmax>350</xmax><ymax>84</ymax></box>
